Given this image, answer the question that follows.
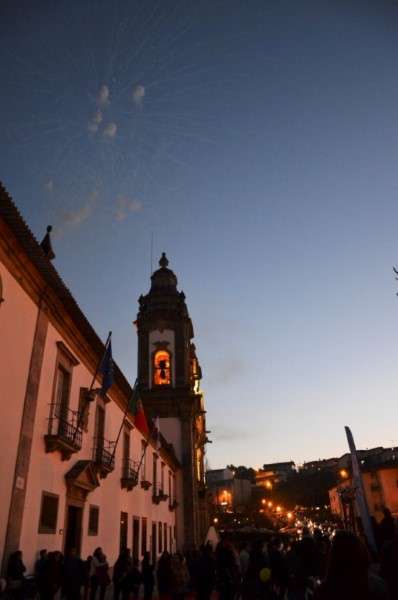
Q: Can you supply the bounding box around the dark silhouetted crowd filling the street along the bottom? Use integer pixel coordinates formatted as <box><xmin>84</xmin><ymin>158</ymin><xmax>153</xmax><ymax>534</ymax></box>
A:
<box><xmin>2</xmin><ymin>510</ymin><xmax>398</xmax><ymax>600</ymax></box>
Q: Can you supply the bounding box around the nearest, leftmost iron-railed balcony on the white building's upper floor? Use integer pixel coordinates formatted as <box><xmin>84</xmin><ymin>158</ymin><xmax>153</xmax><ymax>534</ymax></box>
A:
<box><xmin>44</xmin><ymin>404</ymin><xmax>83</xmax><ymax>460</ymax></box>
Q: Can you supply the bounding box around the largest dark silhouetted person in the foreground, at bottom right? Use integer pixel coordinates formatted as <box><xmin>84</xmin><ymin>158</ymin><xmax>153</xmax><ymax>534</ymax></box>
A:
<box><xmin>317</xmin><ymin>531</ymin><xmax>389</xmax><ymax>600</ymax></box>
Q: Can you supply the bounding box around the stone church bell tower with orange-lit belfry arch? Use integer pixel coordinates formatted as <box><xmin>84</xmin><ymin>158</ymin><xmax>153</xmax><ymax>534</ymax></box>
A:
<box><xmin>136</xmin><ymin>253</ymin><xmax>208</xmax><ymax>549</ymax></box>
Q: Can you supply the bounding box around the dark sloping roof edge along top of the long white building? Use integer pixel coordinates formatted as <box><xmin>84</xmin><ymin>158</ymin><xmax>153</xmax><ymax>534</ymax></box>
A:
<box><xmin>0</xmin><ymin>182</ymin><xmax>179</xmax><ymax>465</ymax></box>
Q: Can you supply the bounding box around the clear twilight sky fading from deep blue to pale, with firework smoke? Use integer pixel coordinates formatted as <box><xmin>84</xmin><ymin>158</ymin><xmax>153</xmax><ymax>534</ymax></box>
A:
<box><xmin>0</xmin><ymin>0</ymin><xmax>398</xmax><ymax>468</ymax></box>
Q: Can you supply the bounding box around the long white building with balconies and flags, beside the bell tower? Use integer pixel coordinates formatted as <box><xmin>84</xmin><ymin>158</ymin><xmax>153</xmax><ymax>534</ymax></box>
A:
<box><xmin>0</xmin><ymin>187</ymin><xmax>181</xmax><ymax>571</ymax></box>
